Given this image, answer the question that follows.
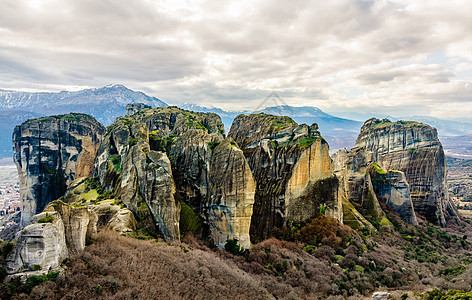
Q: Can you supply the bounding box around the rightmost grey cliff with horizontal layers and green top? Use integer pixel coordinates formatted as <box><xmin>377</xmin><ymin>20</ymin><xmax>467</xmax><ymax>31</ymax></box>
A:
<box><xmin>356</xmin><ymin>118</ymin><xmax>456</xmax><ymax>225</ymax></box>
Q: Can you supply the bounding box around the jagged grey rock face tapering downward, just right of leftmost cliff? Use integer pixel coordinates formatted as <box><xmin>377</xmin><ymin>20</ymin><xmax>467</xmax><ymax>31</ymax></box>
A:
<box><xmin>94</xmin><ymin>111</ymin><xmax>180</xmax><ymax>240</ymax></box>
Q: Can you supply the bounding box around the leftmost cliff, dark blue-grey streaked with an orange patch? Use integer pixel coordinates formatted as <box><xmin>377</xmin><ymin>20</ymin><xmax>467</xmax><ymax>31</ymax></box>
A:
<box><xmin>13</xmin><ymin>113</ymin><xmax>105</xmax><ymax>227</ymax></box>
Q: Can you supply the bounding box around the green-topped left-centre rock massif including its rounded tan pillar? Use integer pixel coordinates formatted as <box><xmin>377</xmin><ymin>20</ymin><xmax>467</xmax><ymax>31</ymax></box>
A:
<box><xmin>95</xmin><ymin>107</ymin><xmax>255</xmax><ymax>248</ymax></box>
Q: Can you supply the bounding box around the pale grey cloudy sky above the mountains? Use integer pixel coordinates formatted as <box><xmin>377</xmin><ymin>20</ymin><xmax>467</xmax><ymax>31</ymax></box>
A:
<box><xmin>0</xmin><ymin>0</ymin><xmax>472</xmax><ymax>120</ymax></box>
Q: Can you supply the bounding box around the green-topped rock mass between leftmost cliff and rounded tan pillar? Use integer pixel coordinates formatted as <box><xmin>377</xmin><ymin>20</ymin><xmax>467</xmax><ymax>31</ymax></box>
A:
<box><xmin>95</xmin><ymin>107</ymin><xmax>224</xmax><ymax>240</ymax></box>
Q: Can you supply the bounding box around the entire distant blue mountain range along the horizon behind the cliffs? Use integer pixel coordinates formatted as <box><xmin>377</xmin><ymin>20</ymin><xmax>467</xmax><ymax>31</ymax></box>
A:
<box><xmin>0</xmin><ymin>84</ymin><xmax>472</xmax><ymax>158</ymax></box>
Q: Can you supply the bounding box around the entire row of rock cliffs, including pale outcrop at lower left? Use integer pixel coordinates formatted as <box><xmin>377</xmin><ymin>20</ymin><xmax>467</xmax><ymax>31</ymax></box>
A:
<box><xmin>7</xmin><ymin>104</ymin><xmax>455</xmax><ymax>274</ymax></box>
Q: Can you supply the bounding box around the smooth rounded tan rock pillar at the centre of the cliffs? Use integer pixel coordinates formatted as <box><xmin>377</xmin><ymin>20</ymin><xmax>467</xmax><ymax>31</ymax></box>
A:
<box><xmin>203</xmin><ymin>138</ymin><xmax>256</xmax><ymax>249</ymax></box>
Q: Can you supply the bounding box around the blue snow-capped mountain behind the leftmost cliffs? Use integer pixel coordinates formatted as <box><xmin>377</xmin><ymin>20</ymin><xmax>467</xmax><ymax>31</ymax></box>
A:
<box><xmin>0</xmin><ymin>84</ymin><xmax>168</xmax><ymax>158</ymax></box>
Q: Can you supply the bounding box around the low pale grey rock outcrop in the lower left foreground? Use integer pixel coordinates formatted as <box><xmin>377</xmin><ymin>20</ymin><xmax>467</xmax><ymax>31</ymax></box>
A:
<box><xmin>6</xmin><ymin>178</ymin><xmax>136</xmax><ymax>274</ymax></box>
